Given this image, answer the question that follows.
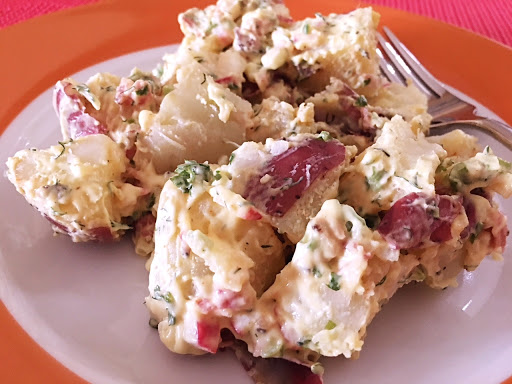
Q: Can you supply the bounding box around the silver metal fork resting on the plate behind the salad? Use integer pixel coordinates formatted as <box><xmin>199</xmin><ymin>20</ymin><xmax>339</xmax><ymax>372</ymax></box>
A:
<box><xmin>377</xmin><ymin>27</ymin><xmax>512</xmax><ymax>150</ymax></box>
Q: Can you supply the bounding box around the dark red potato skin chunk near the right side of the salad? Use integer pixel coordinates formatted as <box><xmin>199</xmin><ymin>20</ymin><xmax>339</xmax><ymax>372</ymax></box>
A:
<box><xmin>378</xmin><ymin>193</ymin><xmax>464</xmax><ymax>249</ymax></box>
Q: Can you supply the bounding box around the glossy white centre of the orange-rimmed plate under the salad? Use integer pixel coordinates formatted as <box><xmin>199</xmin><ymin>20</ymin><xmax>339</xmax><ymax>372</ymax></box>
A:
<box><xmin>0</xmin><ymin>47</ymin><xmax>512</xmax><ymax>384</ymax></box>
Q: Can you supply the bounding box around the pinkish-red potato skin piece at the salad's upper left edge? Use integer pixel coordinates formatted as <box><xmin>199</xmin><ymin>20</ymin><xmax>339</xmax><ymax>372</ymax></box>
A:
<box><xmin>53</xmin><ymin>80</ymin><xmax>107</xmax><ymax>139</ymax></box>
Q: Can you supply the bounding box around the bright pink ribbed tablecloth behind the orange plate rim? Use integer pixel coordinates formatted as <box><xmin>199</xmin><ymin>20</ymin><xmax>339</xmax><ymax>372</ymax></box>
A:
<box><xmin>0</xmin><ymin>0</ymin><xmax>512</xmax><ymax>47</ymax></box>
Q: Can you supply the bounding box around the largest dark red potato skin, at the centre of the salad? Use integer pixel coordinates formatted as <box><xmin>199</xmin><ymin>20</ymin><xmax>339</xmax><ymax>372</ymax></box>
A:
<box><xmin>243</xmin><ymin>139</ymin><xmax>345</xmax><ymax>217</ymax></box>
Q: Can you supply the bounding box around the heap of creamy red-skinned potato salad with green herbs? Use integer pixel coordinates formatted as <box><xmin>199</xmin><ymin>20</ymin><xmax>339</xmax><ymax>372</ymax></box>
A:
<box><xmin>7</xmin><ymin>0</ymin><xmax>512</xmax><ymax>384</ymax></box>
